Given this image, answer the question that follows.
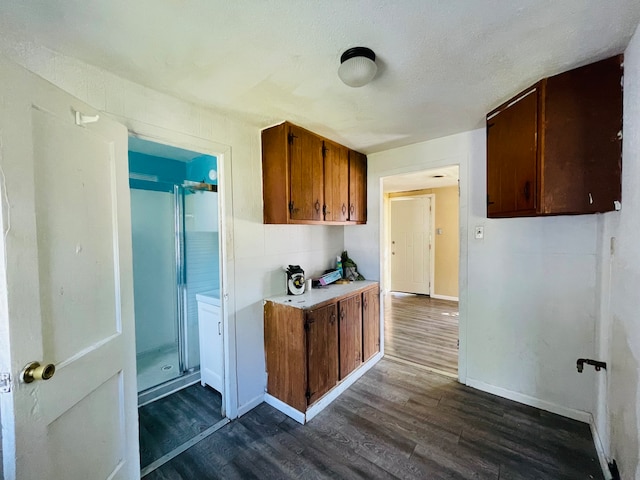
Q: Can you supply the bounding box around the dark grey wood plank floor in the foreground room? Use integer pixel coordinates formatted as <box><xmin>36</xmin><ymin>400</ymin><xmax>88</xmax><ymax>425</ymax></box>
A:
<box><xmin>145</xmin><ymin>358</ymin><xmax>603</xmax><ymax>480</ymax></box>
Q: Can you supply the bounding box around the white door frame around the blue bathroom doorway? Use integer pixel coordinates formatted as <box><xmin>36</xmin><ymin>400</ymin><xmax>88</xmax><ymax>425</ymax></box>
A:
<box><xmin>111</xmin><ymin>114</ymin><xmax>238</xmax><ymax>419</ymax></box>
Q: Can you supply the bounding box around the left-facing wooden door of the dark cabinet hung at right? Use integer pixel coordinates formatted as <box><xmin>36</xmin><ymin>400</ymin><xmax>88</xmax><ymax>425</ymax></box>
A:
<box><xmin>487</xmin><ymin>87</ymin><xmax>538</xmax><ymax>218</ymax></box>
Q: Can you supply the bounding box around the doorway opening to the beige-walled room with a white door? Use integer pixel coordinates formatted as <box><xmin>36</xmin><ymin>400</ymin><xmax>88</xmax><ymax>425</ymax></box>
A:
<box><xmin>382</xmin><ymin>165</ymin><xmax>460</xmax><ymax>378</ymax></box>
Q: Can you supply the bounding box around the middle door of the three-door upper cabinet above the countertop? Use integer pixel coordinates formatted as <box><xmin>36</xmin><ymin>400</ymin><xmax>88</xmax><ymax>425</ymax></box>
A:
<box><xmin>324</xmin><ymin>140</ymin><xmax>349</xmax><ymax>222</ymax></box>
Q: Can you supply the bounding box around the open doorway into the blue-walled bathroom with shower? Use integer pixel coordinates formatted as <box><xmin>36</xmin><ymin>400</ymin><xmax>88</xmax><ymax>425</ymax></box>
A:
<box><xmin>129</xmin><ymin>137</ymin><xmax>227</xmax><ymax>475</ymax></box>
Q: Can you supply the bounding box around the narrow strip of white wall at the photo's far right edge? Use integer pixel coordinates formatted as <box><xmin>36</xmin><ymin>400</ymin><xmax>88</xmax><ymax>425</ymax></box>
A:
<box><xmin>596</xmin><ymin>23</ymin><xmax>640</xmax><ymax>479</ymax></box>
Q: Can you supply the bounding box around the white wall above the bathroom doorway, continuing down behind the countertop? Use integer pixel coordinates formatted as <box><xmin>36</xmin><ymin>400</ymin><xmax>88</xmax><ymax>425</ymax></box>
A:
<box><xmin>0</xmin><ymin>41</ymin><xmax>344</xmax><ymax>414</ymax></box>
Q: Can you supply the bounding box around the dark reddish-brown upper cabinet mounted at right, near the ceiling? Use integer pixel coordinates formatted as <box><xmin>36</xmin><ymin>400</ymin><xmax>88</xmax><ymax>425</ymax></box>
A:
<box><xmin>487</xmin><ymin>56</ymin><xmax>622</xmax><ymax>218</ymax></box>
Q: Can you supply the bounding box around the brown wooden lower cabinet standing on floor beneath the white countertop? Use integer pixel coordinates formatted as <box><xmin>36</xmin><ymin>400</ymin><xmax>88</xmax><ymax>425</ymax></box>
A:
<box><xmin>264</xmin><ymin>282</ymin><xmax>380</xmax><ymax>413</ymax></box>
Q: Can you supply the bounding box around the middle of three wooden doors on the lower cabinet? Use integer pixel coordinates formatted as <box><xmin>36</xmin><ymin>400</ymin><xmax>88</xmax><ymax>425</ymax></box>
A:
<box><xmin>338</xmin><ymin>294</ymin><xmax>362</xmax><ymax>380</ymax></box>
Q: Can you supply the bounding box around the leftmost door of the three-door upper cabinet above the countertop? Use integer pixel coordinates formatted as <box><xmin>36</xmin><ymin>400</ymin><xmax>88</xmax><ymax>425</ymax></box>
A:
<box><xmin>288</xmin><ymin>125</ymin><xmax>324</xmax><ymax>220</ymax></box>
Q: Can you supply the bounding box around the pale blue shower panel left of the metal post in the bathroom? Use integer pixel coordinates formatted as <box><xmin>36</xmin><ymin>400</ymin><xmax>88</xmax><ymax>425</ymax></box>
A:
<box><xmin>131</xmin><ymin>188</ymin><xmax>182</xmax><ymax>392</ymax></box>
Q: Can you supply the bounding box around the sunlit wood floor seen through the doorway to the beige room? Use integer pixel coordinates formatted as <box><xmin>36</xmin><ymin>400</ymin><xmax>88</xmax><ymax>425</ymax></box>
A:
<box><xmin>384</xmin><ymin>293</ymin><xmax>458</xmax><ymax>377</ymax></box>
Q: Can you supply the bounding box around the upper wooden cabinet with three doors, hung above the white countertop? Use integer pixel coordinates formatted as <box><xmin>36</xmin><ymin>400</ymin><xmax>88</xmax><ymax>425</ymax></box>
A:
<box><xmin>262</xmin><ymin>122</ymin><xmax>367</xmax><ymax>225</ymax></box>
